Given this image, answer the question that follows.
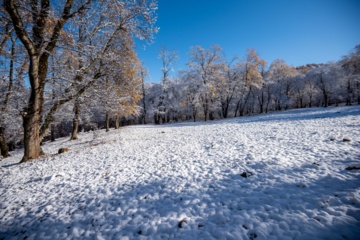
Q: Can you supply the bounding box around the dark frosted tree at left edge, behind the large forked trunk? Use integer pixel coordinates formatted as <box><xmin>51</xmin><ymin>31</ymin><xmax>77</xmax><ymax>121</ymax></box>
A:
<box><xmin>0</xmin><ymin>25</ymin><xmax>28</xmax><ymax>157</ymax></box>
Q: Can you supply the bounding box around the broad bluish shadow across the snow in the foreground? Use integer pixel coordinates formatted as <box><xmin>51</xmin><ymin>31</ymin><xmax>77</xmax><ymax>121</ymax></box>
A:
<box><xmin>0</xmin><ymin>167</ymin><xmax>360</xmax><ymax>239</ymax></box>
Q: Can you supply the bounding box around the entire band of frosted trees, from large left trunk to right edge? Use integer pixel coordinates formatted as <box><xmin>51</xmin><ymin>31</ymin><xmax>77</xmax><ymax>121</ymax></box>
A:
<box><xmin>0</xmin><ymin>0</ymin><xmax>360</xmax><ymax>161</ymax></box>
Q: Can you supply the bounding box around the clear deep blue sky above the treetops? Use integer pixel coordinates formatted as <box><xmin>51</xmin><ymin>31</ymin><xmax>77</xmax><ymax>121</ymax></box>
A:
<box><xmin>137</xmin><ymin>0</ymin><xmax>360</xmax><ymax>82</ymax></box>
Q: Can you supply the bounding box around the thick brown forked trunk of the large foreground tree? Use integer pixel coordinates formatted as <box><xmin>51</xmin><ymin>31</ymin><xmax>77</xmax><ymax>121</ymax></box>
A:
<box><xmin>3</xmin><ymin>0</ymin><xmax>90</xmax><ymax>161</ymax></box>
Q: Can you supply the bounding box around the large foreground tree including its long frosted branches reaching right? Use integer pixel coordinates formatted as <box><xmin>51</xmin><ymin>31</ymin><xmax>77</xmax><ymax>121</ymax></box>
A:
<box><xmin>3</xmin><ymin>0</ymin><xmax>157</xmax><ymax>161</ymax></box>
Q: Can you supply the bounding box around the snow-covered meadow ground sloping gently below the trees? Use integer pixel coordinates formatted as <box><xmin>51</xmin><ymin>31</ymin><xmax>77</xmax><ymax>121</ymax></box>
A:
<box><xmin>0</xmin><ymin>106</ymin><xmax>360</xmax><ymax>240</ymax></box>
